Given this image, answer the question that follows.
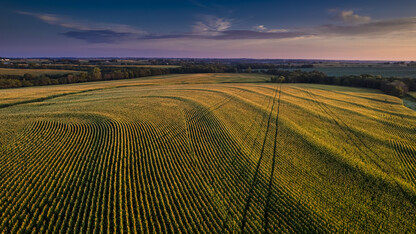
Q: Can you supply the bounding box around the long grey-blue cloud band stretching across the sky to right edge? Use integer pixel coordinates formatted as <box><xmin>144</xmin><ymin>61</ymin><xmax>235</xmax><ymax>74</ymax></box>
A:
<box><xmin>14</xmin><ymin>11</ymin><xmax>416</xmax><ymax>43</ymax></box>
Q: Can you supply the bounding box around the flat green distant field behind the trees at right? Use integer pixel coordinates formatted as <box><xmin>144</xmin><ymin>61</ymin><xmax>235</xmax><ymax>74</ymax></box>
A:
<box><xmin>284</xmin><ymin>67</ymin><xmax>416</xmax><ymax>78</ymax></box>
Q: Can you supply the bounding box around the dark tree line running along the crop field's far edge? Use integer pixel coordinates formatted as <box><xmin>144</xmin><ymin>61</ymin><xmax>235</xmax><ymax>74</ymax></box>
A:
<box><xmin>0</xmin><ymin>63</ymin><xmax>416</xmax><ymax>97</ymax></box>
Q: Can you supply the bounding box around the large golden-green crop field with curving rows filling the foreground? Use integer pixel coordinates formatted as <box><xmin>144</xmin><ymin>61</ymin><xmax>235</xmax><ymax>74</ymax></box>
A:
<box><xmin>0</xmin><ymin>74</ymin><xmax>416</xmax><ymax>233</ymax></box>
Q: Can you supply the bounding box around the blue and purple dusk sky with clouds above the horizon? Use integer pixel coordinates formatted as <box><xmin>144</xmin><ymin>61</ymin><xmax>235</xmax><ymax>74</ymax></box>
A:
<box><xmin>0</xmin><ymin>0</ymin><xmax>416</xmax><ymax>60</ymax></box>
